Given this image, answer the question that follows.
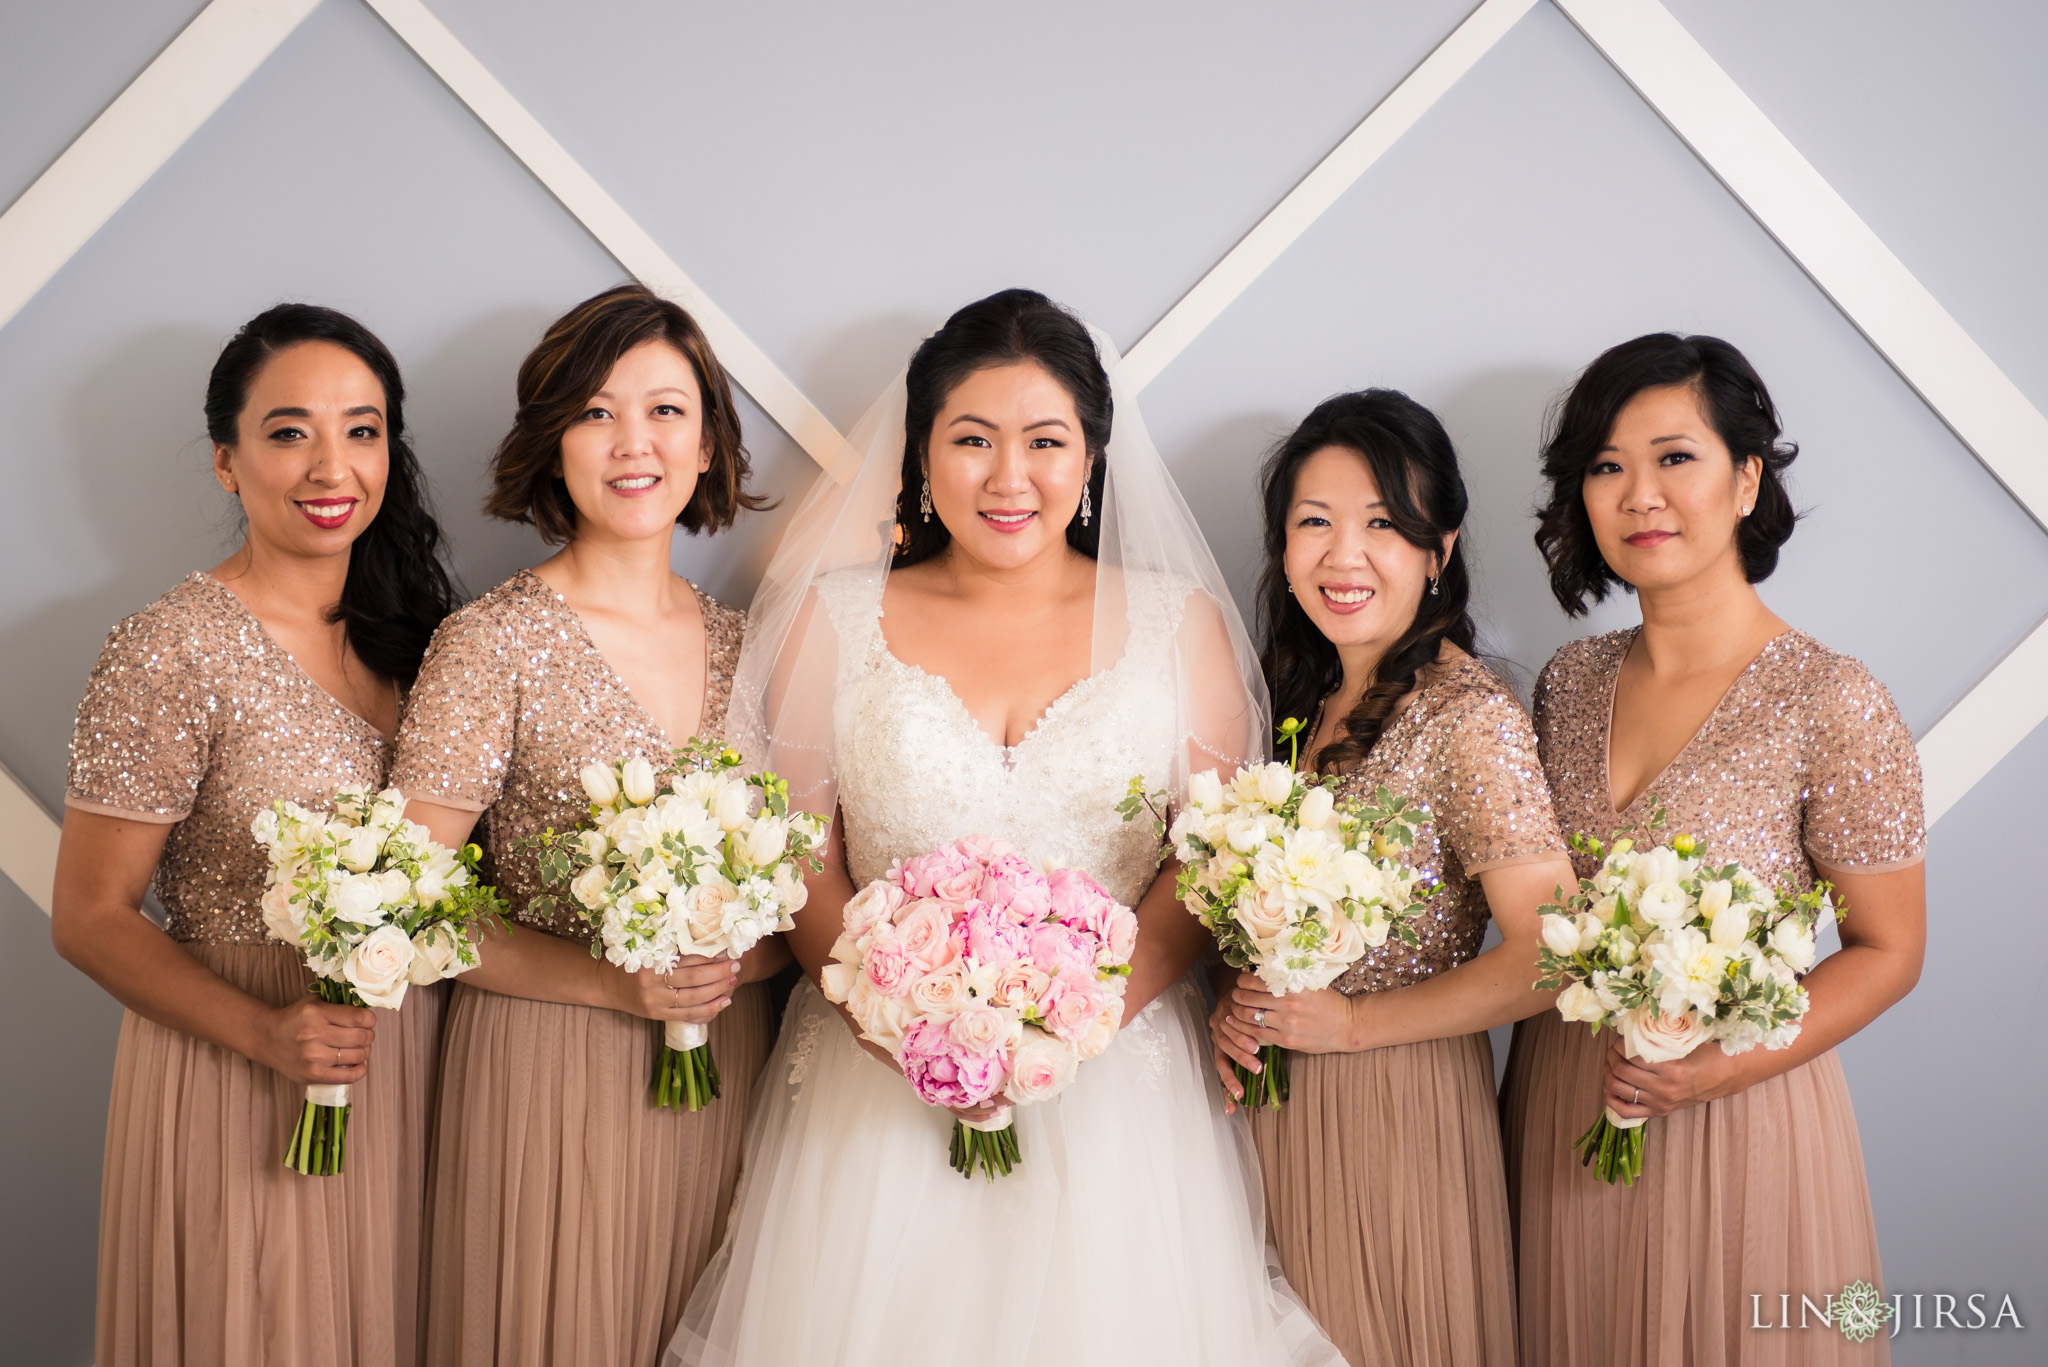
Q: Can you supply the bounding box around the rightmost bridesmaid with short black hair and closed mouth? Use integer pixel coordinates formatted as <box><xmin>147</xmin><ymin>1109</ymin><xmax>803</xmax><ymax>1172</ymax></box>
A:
<box><xmin>1503</xmin><ymin>334</ymin><xmax>1925</xmax><ymax>1367</ymax></box>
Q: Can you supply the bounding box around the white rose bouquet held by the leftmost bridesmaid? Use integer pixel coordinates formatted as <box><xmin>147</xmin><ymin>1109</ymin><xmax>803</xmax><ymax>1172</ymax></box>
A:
<box><xmin>250</xmin><ymin>785</ymin><xmax>506</xmax><ymax>1176</ymax></box>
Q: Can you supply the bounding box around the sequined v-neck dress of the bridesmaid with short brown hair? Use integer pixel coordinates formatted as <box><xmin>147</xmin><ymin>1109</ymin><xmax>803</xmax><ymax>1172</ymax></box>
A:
<box><xmin>391</xmin><ymin>570</ymin><xmax>772</xmax><ymax>1367</ymax></box>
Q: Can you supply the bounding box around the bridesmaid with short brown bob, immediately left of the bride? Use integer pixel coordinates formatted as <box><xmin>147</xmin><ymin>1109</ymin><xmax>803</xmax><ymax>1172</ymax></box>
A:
<box><xmin>393</xmin><ymin>285</ymin><xmax>786</xmax><ymax>1367</ymax></box>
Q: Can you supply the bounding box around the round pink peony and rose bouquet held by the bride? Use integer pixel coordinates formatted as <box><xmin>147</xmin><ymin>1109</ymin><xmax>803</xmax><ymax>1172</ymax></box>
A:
<box><xmin>823</xmin><ymin>836</ymin><xmax>1139</xmax><ymax>1180</ymax></box>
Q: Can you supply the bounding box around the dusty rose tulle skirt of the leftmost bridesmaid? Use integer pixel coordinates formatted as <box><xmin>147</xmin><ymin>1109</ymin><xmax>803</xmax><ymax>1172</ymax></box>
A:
<box><xmin>92</xmin><ymin>945</ymin><xmax>446</xmax><ymax>1367</ymax></box>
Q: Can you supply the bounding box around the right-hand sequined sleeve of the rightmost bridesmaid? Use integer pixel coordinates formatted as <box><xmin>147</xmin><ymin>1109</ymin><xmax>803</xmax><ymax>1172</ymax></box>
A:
<box><xmin>1800</xmin><ymin>656</ymin><xmax>1927</xmax><ymax>873</ymax></box>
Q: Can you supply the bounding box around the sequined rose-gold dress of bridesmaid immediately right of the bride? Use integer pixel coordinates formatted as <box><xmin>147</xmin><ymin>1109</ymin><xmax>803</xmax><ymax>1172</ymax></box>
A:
<box><xmin>1251</xmin><ymin>656</ymin><xmax>1565</xmax><ymax>1367</ymax></box>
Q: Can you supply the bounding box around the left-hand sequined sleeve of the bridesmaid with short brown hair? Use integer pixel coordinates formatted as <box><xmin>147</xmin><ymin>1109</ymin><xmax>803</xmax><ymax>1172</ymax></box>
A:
<box><xmin>391</xmin><ymin>598</ymin><xmax>522</xmax><ymax>812</ymax></box>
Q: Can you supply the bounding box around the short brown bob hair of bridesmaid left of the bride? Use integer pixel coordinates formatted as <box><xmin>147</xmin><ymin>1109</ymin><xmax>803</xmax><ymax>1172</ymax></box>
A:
<box><xmin>483</xmin><ymin>285</ymin><xmax>772</xmax><ymax>545</ymax></box>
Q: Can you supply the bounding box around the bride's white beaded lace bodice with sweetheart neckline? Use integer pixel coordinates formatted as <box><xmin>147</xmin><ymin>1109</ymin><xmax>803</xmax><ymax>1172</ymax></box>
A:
<box><xmin>817</xmin><ymin>572</ymin><xmax>1186</xmax><ymax>906</ymax></box>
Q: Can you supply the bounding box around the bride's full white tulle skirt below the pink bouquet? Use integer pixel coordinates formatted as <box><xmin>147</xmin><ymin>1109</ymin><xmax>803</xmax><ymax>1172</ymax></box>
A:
<box><xmin>666</xmin><ymin>980</ymin><xmax>1343</xmax><ymax>1367</ymax></box>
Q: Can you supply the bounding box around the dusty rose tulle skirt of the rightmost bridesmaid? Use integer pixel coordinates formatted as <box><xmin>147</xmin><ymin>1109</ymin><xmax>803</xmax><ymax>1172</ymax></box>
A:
<box><xmin>1501</xmin><ymin>1010</ymin><xmax>1890</xmax><ymax>1367</ymax></box>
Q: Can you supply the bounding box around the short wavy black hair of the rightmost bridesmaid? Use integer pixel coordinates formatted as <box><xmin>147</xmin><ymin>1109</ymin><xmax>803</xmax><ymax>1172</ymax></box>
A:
<box><xmin>1536</xmin><ymin>332</ymin><xmax>1798</xmax><ymax>617</ymax></box>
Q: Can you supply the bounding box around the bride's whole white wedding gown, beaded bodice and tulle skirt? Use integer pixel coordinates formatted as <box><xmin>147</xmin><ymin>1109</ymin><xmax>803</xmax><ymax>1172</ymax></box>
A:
<box><xmin>668</xmin><ymin>576</ymin><xmax>1341</xmax><ymax>1367</ymax></box>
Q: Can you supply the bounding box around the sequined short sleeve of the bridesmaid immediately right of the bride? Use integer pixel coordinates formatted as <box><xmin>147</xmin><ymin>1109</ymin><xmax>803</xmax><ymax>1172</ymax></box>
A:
<box><xmin>1436</xmin><ymin>691</ymin><xmax>1565</xmax><ymax>877</ymax></box>
